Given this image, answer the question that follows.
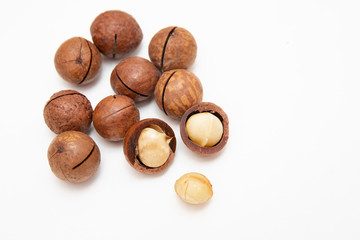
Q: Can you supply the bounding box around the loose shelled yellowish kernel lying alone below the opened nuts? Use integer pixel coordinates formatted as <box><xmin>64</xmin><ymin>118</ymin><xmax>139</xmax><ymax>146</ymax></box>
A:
<box><xmin>175</xmin><ymin>172</ymin><xmax>213</xmax><ymax>204</ymax></box>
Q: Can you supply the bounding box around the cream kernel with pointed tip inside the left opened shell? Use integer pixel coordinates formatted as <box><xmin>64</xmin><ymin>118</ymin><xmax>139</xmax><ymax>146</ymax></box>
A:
<box><xmin>138</xmin><ymin>125</ymin><xmax>171</xmax><ymax>168</ymax></box>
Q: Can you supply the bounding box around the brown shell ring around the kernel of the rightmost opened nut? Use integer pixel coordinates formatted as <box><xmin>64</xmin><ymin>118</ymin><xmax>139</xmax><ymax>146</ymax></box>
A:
<box><xmin>180</xmin><ymin>102</ymin><xmax>229</xmax><ymax>155</ymax></box>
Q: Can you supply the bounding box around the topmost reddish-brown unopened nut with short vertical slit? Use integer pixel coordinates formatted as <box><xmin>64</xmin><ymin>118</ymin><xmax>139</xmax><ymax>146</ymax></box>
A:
<box><xmin>90</xmin><ymin>10</ymin><xmax>143</xmax><ymax>58</ymax></box>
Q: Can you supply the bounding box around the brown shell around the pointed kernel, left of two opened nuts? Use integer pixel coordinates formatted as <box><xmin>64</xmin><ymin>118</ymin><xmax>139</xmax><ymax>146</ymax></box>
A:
<box><xmin>124</xmin><ymin>118</ymin><xmax>176</xmax><ymax>174</ymax></box>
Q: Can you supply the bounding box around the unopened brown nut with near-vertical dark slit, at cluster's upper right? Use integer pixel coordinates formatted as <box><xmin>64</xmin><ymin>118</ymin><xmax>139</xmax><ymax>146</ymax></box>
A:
<box><xmin>149</xmin><ymin>27</ymin><xmax>197</xmax><ymax>72</ymax></box>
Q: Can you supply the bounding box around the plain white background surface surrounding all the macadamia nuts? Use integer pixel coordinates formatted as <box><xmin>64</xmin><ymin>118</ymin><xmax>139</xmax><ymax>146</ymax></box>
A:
<box><xmin>0</xmin><ymin>0</ymin><xmax>360</xmax><ymax>240</ymax></box>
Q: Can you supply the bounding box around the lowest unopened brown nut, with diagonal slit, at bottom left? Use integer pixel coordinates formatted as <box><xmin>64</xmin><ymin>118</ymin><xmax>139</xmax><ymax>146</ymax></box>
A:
<box><xmin>47</xmin><ymin>131</ymin><xmax>100</xmax><ymax>183</ymax></box>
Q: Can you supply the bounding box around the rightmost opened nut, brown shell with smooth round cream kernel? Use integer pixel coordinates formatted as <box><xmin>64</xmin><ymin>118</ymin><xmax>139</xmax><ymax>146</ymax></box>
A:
<box><xmin>180</xmin><ymin>102</ymin><xmax>229</xmax><ymax>155</ymax></box>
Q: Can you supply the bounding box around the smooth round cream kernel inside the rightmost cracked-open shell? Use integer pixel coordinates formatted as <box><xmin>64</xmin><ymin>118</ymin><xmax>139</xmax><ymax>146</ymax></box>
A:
<box><xmin>185</xmin><ymin>112</ymin><xmax>223</xmax><ymax>147</ymax></box>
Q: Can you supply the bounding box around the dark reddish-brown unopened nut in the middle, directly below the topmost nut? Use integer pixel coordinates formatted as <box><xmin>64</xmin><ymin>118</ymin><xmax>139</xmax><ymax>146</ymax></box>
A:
<box><xmin>110</xmin><ymin>56</ymin><xmax>160</xmax><ymax>102</ymax></box>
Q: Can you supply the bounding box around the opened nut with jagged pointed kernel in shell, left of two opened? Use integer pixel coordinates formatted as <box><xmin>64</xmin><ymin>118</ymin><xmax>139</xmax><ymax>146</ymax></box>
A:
<box><xmin>124</xmin><ymin>118</ymin><xmax>176</xmax><ymax>174</ymax></box>
